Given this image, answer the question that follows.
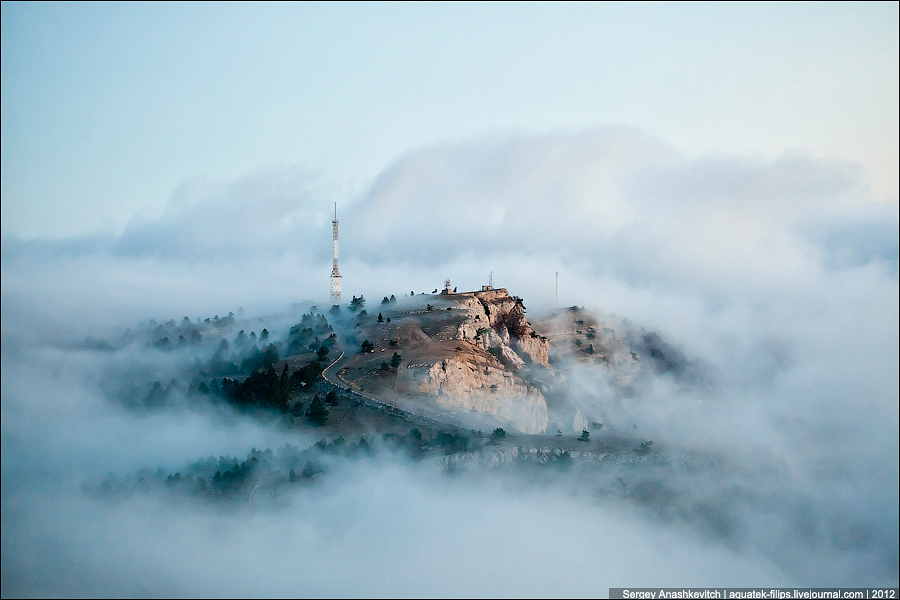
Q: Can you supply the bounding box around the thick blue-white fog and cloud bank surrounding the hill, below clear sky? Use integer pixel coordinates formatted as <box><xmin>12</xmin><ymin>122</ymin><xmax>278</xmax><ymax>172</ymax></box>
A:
<box><xmin>2</xmin><ymin>129</ymin><xmax>900</xmax><ymax>597</ymax></box>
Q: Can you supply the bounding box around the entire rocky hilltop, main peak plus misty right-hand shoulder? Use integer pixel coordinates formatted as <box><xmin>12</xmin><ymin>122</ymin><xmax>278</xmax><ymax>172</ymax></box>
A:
<box><xmin>339</xmin><ymin>288</ymin><xmax>688</xmax><ymax>434</ymax></box>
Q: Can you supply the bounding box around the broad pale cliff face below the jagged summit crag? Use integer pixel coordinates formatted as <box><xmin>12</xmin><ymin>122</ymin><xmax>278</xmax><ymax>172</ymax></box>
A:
<box><xmin>397</xmin><ymin>354</ymin><xmax>547</xmax><ymax>433</ymax></box>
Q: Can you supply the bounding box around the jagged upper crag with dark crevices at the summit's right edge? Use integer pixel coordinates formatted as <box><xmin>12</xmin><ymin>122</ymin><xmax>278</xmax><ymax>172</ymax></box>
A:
<box><xmin>457</xmin><ymin>288</ymin><xmax>550</xmax><ymax>369</ymax></box>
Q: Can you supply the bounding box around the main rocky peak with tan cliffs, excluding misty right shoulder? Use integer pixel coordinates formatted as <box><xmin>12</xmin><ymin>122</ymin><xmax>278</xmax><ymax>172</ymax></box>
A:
<box><xmin>341</xmin><ymin>289</ymin><xmax>549</xmax><ymax>433</ymax></box>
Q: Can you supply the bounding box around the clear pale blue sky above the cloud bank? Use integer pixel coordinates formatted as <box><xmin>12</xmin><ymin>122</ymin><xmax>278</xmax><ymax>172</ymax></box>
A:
<box><xmin>2</xmin><ymin>2</ymin><xmax>900</xmax><ymax>238</ymax></box>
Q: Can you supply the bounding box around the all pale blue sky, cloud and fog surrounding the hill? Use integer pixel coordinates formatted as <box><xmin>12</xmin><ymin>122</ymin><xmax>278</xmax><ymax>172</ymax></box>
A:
<box><xmin>0</xmin><ymin>2</ymin><xmax>900</xmax><ymax>597</ymax></box>
